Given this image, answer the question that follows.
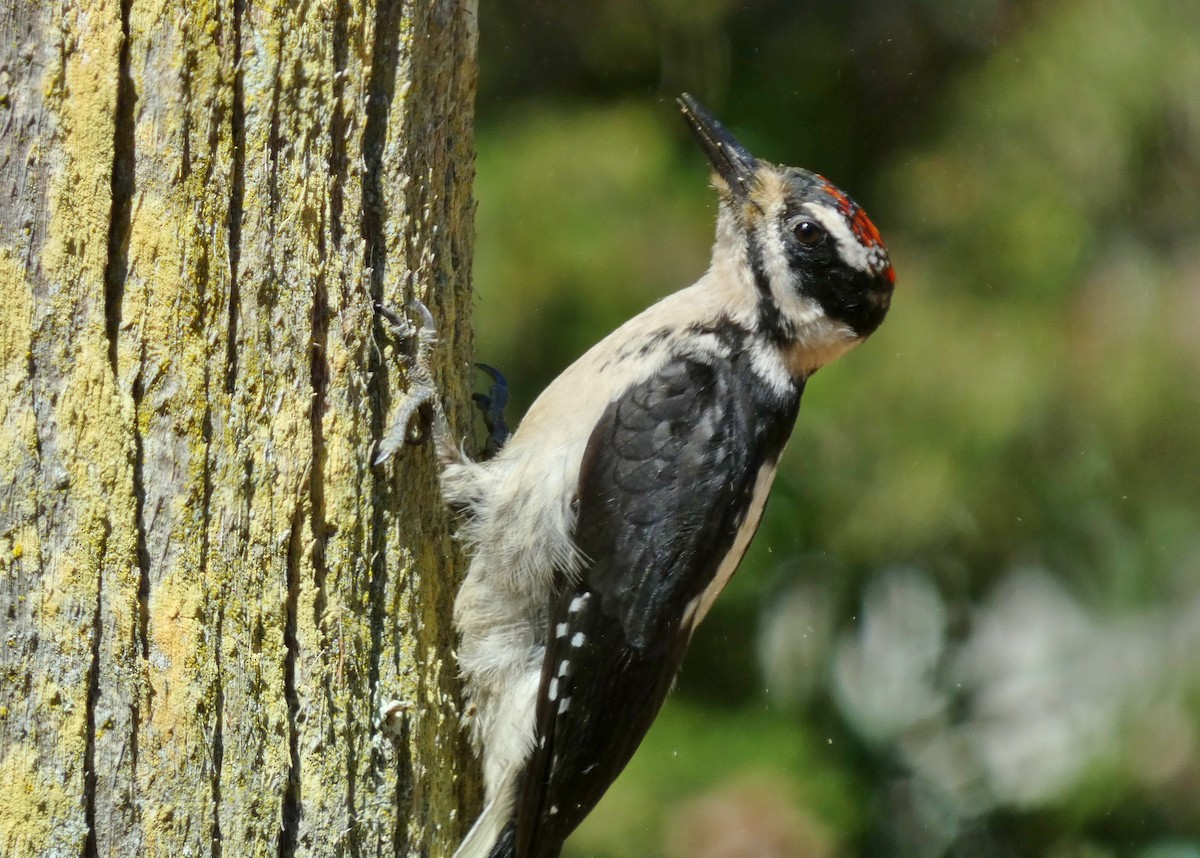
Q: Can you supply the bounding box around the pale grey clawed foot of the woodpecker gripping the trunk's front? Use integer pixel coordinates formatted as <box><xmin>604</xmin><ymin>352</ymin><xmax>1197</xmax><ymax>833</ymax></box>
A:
<box><xmin>374</xmin><ymin>300</ymin><xmax>455</xmax><ymax>464</ymax></box>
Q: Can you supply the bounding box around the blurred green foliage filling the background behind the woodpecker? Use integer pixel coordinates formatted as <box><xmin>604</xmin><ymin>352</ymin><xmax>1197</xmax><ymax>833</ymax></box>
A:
<box><xmin>465</xmin><ymin>0</ymin><xmax>1200</xmax><ymax>858</ymax></box>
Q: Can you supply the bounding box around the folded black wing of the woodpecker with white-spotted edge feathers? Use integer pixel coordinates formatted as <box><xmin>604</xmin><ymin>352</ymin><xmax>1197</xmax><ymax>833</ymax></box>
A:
<box><xmin>516</xmin><ymin>358</ymin><xmax>798</xmax><ymax>858</ymax></box>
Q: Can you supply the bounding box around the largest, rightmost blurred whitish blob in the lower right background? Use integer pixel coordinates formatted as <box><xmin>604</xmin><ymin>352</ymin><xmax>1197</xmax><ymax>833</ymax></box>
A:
<box><xmin>953</xmin><ymin>571</ymin><xmax>1164</xmax><ymax>806</ymax></box>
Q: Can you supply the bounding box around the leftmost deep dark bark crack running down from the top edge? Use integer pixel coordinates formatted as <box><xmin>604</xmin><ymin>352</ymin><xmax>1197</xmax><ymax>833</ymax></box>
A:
<box><xmin>104</xmin><ymin>0</ymin><xmax>137</xmax><ymax>376</ymax></box>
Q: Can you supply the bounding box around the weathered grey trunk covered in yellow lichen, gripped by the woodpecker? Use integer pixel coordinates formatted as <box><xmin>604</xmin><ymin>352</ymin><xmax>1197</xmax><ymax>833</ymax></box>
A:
<box><xmin>0</xmin><ymin>0</ymin><xmax>475</xmax><ymax>857</ymax></box>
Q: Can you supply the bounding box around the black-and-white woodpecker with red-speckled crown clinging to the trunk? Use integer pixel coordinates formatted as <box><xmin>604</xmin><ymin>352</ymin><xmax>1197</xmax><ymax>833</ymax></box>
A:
<box><xmin>379</xmin><ymin>95</ymin><xmax>895</xmax><ymax>858</ymax></box>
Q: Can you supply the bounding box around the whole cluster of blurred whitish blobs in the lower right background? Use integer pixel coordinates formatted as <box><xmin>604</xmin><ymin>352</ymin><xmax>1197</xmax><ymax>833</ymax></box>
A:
<box><xmin>761</xmin><ymin>569</ymin><xmax>1200</xmax><ymax>856</ymax></box>
